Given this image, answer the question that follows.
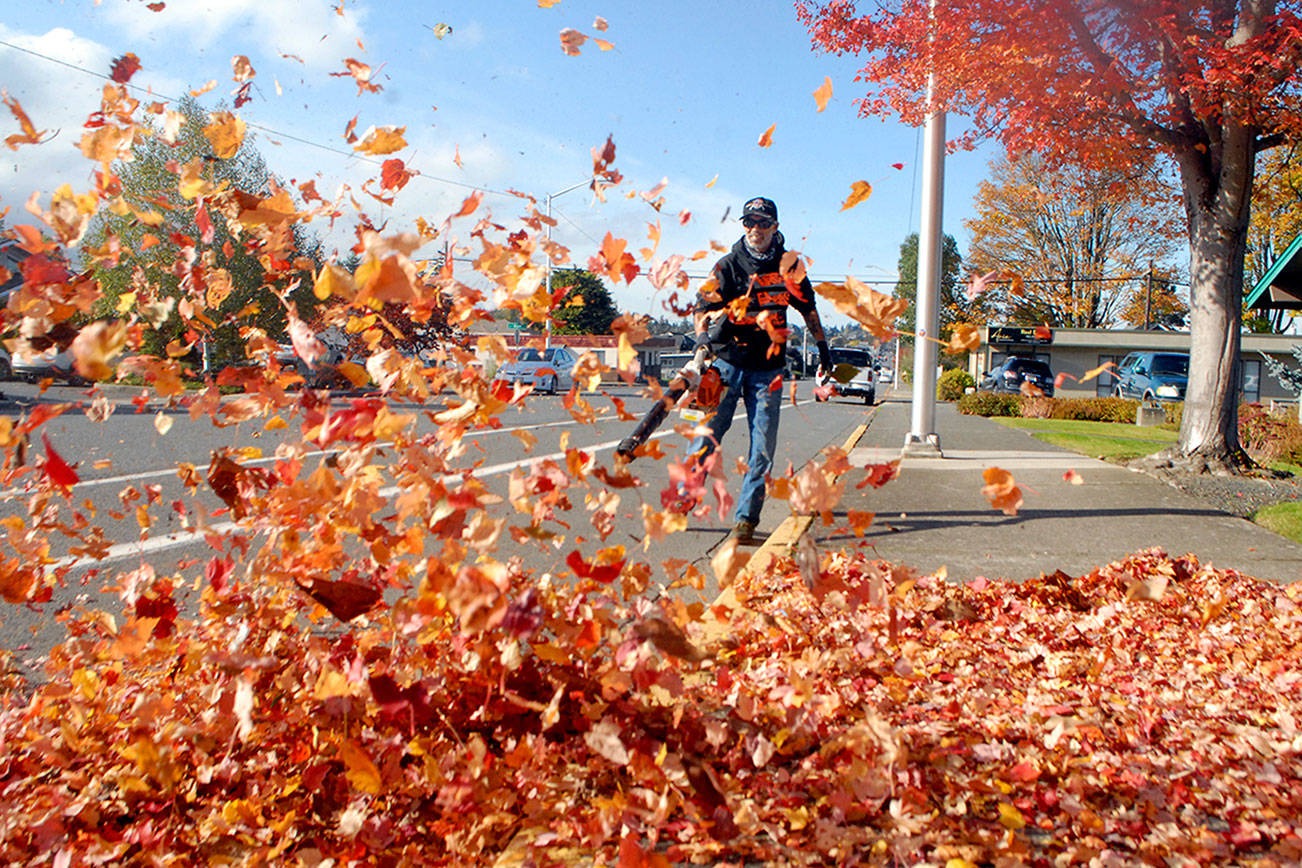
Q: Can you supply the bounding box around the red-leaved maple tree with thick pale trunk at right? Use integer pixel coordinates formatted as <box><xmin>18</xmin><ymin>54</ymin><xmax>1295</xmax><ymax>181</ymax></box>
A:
<box><xmin>797</xmin><ymin>0</ymin><xmax>1302</xmax><ymax>471</ymax></box>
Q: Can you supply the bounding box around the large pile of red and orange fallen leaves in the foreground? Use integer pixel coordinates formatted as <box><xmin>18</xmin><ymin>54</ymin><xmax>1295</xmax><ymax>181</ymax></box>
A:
<box><xmin>0</xmin><ymin>552</ymin><xmax>1302</xmax><ymax>868</ymax></box>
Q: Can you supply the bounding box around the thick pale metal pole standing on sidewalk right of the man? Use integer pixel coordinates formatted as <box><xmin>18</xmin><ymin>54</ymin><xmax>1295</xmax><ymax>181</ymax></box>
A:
<box><xmin>904</xmin><ymin>59</ymin><xmax>945</xmax><ymax>455</ymax></box>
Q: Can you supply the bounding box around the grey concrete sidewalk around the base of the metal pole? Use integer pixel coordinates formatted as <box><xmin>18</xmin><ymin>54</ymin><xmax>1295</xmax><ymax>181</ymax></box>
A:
<box><xmin>807</xmin><ymin>393</ymin><xmax>1302</xmax><ymax>582</ymax></box>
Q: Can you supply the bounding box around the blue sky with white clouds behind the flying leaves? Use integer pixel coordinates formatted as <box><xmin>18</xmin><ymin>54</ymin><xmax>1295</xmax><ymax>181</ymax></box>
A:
<box><xmin>0</xmin><ymin>0</ymin><xmax>996</xmax><ymax>322</ymax></box>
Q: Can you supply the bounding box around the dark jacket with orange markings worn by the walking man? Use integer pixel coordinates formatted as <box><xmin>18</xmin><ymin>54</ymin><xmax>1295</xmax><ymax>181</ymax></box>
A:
<box><xmin>697</xmin><ymin>233</ymin><xmax>814</xmax><ymax>371</ymax></box>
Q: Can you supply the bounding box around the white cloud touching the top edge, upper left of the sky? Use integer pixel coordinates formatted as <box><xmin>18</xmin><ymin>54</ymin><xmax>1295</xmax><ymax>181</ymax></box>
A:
<box><xmin>97</xmin><ymin>0</ymin><xmax>367</xmax><ymax>69</ymax></box>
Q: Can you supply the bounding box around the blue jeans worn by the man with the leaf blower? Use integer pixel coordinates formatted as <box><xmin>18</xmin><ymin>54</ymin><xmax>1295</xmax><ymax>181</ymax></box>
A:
<box><xmin>690</xmin><ymin>359</ymin><xmax>783</xmax><ymax>522</ymax></box>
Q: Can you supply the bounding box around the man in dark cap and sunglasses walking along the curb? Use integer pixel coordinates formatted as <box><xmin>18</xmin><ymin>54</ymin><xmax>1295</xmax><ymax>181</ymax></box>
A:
<box><xmin>689</xmin><ymin>197</ymin><xmax>832</xmax><ymax>544</ymax></box>
